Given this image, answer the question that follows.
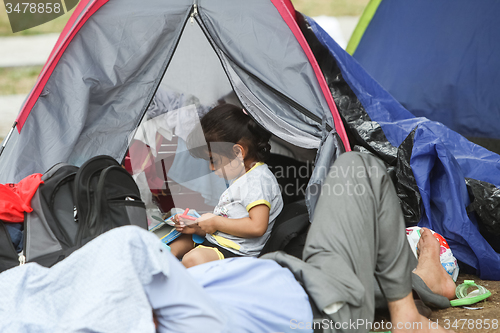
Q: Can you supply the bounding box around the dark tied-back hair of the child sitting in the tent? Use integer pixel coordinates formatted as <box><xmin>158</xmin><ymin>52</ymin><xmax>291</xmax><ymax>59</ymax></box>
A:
<box><xmin>187</xmin><ymin>104</ymin><xmax>271</xmax><ymax>162</ymax></box>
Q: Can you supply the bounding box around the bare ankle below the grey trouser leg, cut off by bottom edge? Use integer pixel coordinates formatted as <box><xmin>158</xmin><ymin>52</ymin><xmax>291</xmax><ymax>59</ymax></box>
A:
<box><xmin>388</xmin><ymin>293</ymin><xmax>449</xmax><ymax>333</ymax></box>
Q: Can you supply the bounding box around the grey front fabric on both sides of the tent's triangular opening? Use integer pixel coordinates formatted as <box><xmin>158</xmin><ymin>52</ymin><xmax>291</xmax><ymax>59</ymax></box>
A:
<box><xmin>0</xmin><ymin>0</ymin><xmax>348</xmax><ymax>182</ymax></box>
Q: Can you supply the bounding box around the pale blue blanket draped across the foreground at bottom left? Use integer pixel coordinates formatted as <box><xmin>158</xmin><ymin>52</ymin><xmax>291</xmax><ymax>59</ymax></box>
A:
<box><xmin>0</xmin><ymin>226</ymin><xmax>312</xmax><ymax>333</ymax></box>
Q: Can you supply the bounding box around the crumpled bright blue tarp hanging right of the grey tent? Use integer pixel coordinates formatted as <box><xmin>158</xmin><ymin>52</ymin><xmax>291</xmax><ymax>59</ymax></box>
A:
<box><xmin>308</xmin><ymin>19</ymin><xmax>500</xmax><ymax>280</ymax></box>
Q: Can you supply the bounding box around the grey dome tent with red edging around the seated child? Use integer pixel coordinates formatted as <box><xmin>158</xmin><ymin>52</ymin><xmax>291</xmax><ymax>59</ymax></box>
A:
<box><xmin>0</xmin><ymin>0</ymin><xmax>350</xmax><ymax>217</ymax></box>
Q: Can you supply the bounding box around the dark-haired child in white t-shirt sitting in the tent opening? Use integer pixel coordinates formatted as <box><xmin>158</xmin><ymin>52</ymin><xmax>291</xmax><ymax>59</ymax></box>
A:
<box><xmin>170</xmin><ymin>104</ymin><xmax>283</xmax><ymax>267</ymax></box>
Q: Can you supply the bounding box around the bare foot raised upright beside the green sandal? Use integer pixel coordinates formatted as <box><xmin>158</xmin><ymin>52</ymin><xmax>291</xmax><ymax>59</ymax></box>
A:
<box><xmin>413</xmin><ymin>228</ymin><xmax>455</xmax><ymax>299</ymax></box>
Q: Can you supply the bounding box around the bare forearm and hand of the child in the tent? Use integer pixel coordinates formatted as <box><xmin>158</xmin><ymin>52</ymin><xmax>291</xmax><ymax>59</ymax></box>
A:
<box><xmin>196</xmin><ymin>205</ymin><xmax>269</xmax><ymax>238</ymax></box>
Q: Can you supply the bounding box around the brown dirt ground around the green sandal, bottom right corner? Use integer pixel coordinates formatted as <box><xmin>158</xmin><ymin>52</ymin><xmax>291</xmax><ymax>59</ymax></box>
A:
<box><xmin>376</xmin><ymin>274</ymin><xmax>500</xmax><ymax>333</ymax></box>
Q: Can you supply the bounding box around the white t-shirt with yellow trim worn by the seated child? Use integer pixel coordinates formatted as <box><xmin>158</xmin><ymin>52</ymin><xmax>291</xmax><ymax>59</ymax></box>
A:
<box><xmin>205</xmin><ymin>162</ymin><xmax>283</xmax><ymax>256</ymax></box>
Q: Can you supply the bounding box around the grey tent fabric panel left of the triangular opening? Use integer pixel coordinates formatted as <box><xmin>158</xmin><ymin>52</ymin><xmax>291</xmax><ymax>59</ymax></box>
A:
<box><xmin>0</xmin><ymin>0</ymin><xmax>192</xmax><ymax>182</ymax></box>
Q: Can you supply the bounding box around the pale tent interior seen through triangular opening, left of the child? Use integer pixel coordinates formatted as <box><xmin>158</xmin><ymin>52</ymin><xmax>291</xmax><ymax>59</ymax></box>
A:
<box><xmin>125</xmin><ymin>18</ymin><xmax>230</xmax><ymax>218</ymax></box>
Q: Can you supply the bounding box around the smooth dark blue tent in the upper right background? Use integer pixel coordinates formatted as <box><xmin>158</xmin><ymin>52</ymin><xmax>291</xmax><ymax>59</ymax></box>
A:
<box><xmin>352</xmin><ymin>0</ymin><xmax>500</xmax><ymax>142</ymax></box>
